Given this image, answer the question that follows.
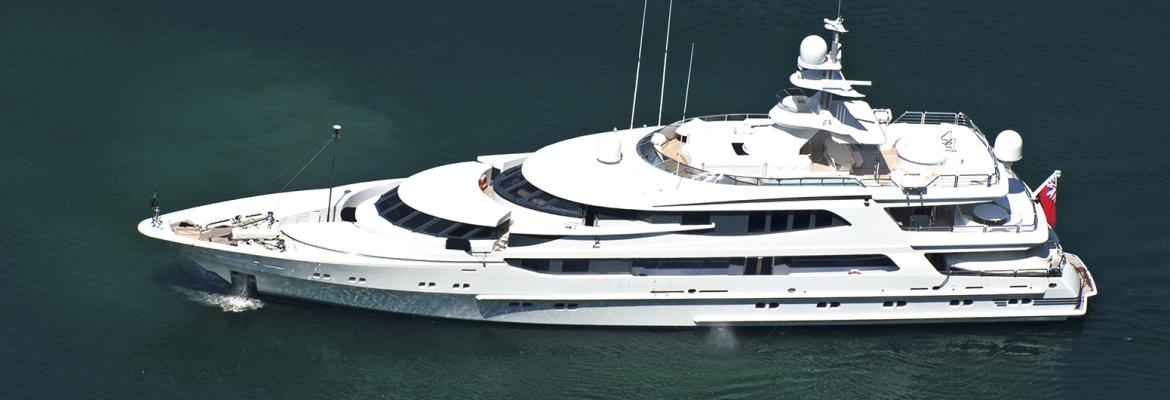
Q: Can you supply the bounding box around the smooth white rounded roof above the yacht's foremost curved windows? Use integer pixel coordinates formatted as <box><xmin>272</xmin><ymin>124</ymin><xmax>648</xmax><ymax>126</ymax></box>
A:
<box><xmin>398</xmin><ymin>161</ymin><xmax>511</xmax><ymax>227</ymax></box>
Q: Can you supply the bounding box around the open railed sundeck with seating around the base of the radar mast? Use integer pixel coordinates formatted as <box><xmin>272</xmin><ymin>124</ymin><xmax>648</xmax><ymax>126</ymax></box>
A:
<box><xmin>636</xmin><ymin>111</ymin><xmax>1000</xmax><ymax>191</ymax></box>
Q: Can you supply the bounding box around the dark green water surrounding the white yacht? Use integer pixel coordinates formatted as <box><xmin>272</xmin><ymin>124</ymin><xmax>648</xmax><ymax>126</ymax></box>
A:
<box><xmin>0</xmin><ymin>0</ymin><xmax>1170</xmax><ymax>399</ymax></box>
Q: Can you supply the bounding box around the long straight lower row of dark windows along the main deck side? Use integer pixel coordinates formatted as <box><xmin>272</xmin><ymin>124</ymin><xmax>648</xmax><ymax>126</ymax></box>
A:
<box><xmin>505</xmin><ymin>255</ymin><xmax>897</xmax><ymax>276</ymax></box>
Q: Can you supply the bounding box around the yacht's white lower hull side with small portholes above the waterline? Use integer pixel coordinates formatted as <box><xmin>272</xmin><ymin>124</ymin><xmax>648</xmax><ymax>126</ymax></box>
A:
<box><xmin>184</xmin><ymin>247</ymin><xmax>1095</xmax><ymax>326</ymax></box>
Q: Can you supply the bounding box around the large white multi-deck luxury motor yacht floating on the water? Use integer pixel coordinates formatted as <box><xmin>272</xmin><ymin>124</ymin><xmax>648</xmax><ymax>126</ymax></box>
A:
<box><xmin>138</xmin><ymin>18</ymin><xmax>1096</xmax><ymax>326</ymax></box>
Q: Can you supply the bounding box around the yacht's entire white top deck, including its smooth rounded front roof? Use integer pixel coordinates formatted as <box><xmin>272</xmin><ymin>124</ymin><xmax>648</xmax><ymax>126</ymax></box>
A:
<box><xmin>523</xmin><ymin>113</ymin><xmax>1009</xmax><ymax>211</ymax></box>
